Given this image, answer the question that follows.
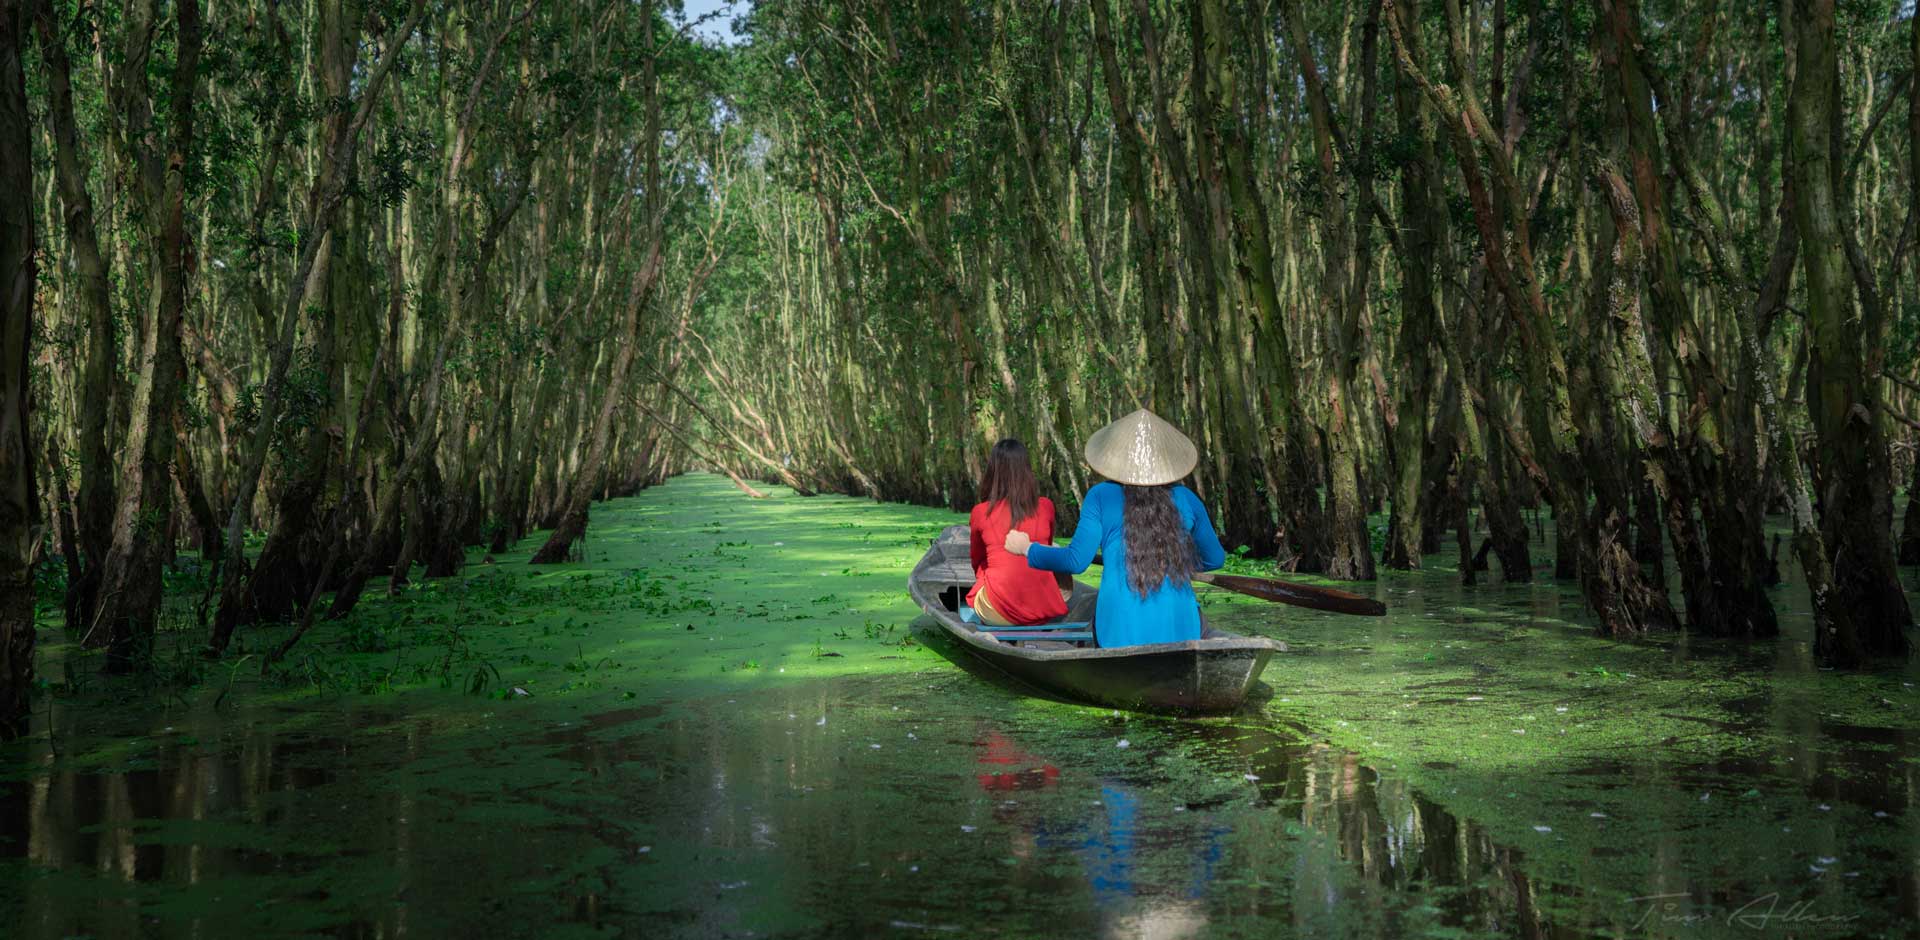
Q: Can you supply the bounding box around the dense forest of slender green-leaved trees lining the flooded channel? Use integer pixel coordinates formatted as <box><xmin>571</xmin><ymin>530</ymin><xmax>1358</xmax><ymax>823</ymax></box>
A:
<box><xmin>0</xmin><ymin>0</ymin><xmax>1920</xmax><ymax>732</ymax></box>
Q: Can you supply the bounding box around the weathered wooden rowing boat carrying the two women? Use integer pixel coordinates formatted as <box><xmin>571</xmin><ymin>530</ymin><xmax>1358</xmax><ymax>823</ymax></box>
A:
<box><xmin>906</xmin><ymin>526</ymin><xmax>1286</xmax><ymax>712</ymax></box>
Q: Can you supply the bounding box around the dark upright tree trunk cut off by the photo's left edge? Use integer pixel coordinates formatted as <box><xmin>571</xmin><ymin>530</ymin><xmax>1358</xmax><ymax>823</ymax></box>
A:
<box><xmin>0</xmin><ymin>2</ymin><xmax>38</xmax><ymax>740</ymax></box>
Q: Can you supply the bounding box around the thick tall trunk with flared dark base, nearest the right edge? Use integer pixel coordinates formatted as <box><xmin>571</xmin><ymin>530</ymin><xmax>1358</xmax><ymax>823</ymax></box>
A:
<box><xmin>1788</xmin><ymin>0</ymin><xmax>1912</xmax><ymax>666</ymax></box>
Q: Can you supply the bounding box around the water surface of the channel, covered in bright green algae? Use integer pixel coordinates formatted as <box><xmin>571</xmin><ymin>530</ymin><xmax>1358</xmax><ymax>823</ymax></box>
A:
<box><xmin>0</xmin><ymin>476</ymin><xmax>1920</xmax><ymax>938</ymax></box>
